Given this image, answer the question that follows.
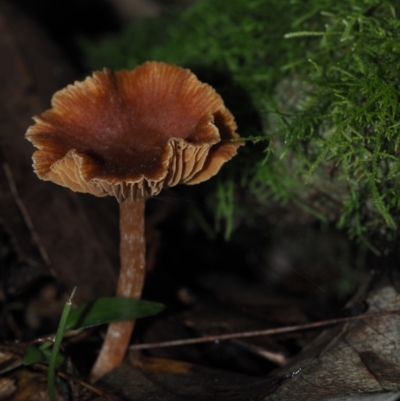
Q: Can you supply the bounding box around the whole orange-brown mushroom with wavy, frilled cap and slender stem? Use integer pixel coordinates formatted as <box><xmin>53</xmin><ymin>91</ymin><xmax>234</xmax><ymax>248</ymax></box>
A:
<box><xmin>26</xmin><ymin>62</ymin><xmax>242</xmax><ymax>381</ymax></box>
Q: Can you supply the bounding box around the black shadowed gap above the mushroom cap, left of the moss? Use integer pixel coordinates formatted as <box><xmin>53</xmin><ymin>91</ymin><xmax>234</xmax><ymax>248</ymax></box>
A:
<box><xmin>9</xmin><ymin>0</ymin><xmax>195</xmax><ymax>72</ymax></box>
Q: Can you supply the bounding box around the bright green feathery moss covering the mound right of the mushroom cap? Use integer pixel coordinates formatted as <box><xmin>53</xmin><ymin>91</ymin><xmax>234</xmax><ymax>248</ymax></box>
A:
<box><xmin>85</xmin><ymin>0</ymin><xmax>400</xmax><ymax>246</ymax></box>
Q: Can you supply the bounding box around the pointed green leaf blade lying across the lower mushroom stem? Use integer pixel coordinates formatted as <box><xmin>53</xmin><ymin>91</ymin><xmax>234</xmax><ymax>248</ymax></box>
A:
<box><xmin>65</xmin><ymin>297</ymin><xmax>164</xmax><ymax>330</ymax></box>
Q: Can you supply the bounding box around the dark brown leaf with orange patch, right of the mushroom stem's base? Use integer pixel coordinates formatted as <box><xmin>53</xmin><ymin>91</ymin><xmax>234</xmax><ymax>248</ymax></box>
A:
<box><xmin>94</xmin><ymin>357</ymin><xmax>272</xmax><ymax>401</ymax></box>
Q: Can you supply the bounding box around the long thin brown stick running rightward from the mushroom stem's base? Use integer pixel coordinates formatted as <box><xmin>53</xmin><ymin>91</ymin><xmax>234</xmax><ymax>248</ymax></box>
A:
<box><xmin>129</xmin><ymin>310</ymin><xmax>400</xmax><ymax>350</ymax></box>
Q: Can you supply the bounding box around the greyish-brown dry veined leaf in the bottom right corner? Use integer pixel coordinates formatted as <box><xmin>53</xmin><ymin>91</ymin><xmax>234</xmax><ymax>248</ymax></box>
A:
<box><xmin>265</xmin><ymin>277</ymin><xmax>400</xmax><ymax>401</ymax></box>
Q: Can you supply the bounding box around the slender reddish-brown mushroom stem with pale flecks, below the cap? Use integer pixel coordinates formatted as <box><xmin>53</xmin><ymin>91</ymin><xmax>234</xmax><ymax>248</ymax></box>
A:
<box><xmin>90</xmin><ymin>196</ymin><xmax>145</xmax><ymax>382</ymax></box>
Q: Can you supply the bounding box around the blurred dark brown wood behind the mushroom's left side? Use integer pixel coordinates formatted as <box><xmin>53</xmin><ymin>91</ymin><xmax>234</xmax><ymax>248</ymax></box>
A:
<box><xmin>0</xmin><ymin>0</ymin><xmax>118</xmax><ymax>302</ymax></box>
